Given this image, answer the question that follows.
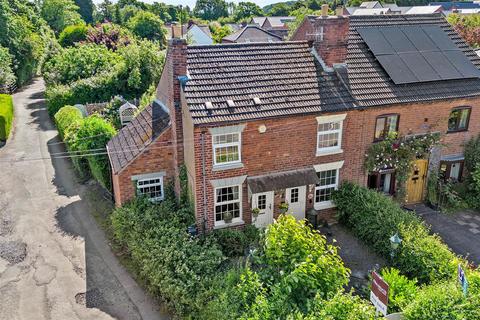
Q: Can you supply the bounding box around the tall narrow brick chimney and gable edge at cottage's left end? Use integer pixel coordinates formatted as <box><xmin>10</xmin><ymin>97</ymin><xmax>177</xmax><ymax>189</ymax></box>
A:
<box><xmin>156</xmin><ymin>38</ymin><xmax>187</xmax><ymax>191</ymax></box>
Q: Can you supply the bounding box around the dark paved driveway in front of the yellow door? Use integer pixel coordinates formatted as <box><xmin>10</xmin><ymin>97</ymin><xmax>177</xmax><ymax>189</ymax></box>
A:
<box><xmin>414</xmin><ymin>204</ymin><xmax>480</xmax><ymax>265</ymax></box>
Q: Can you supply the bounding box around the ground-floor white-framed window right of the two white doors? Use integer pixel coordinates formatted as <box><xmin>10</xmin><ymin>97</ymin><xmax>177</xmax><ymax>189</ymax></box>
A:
<box><xmin>314</xmin><ymin>161</ymin><xmax>343</xmax><ymax>210</ymax></box>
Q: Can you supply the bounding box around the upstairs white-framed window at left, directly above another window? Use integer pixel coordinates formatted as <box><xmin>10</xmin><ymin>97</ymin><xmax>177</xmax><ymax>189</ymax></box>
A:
<box><xmin>212</xmin><ymin>132</ymin><xmax>241</xmax><ymax>165</ymax></box>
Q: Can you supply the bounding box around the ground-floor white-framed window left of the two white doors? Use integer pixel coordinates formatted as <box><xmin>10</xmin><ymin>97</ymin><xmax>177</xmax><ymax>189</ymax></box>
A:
<box><xmin>215</xmin><ymin>186</ymin><xmax>242</xmax><ymax>224</ymax></box>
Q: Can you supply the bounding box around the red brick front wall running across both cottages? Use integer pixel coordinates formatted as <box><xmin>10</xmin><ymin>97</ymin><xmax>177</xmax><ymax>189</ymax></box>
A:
<box><xmin>187</xmin><ymin>98</ymin><xmax>480</xmax><ymax>229</ymax></box>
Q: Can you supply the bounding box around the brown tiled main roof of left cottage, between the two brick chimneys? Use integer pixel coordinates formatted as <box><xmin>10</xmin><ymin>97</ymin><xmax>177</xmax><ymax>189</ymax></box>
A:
<box><xmin>184</xmin><ymin>42</ymin><xmax>354</xmax><ymax>124</ymax></box>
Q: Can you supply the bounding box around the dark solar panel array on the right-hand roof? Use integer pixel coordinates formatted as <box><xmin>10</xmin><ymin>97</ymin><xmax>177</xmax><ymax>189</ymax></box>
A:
<box><xmin>357</xmin><ymin>25</ymin><xmax>480</xmax><ymax>84</ymax></box>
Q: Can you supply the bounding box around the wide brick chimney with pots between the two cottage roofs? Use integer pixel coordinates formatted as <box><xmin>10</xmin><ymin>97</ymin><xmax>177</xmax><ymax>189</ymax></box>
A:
<box><xmin>291</xmin><ymin>4</ymin><xmax>349</xmax><ymax>67</ymax></box>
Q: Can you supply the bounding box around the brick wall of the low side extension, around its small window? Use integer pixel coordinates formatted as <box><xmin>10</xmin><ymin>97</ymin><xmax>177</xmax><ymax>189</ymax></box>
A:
<box><xmin>113</xmin><ymin>128</ymin><xmax>175</xmax><ymax>206</ymax></box>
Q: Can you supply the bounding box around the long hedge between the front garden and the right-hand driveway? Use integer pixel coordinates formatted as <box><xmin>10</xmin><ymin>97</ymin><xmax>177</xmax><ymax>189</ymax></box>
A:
<box><xmin>333</xmin><ymin>182</ymin><xmax>461</xmax><ymax>283</ymax></box>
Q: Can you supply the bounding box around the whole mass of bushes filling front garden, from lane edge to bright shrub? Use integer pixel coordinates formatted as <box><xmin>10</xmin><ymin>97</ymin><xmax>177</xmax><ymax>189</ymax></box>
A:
<box><xmin>111</xmin><ymin>197</ymin><xmax>375</xmax><ymax>320</ymax></box>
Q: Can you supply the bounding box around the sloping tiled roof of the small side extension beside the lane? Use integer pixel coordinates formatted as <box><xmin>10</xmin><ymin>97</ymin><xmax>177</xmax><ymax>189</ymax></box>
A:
<box><xmin>107</xmin><ymin>102</ymin><xmax>170</xmax><ymax>173</ymax></box>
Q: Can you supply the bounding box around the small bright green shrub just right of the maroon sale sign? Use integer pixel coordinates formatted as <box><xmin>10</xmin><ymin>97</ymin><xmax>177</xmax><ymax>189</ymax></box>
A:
<box><xmin>380</xmin><ymin>268</ymin><xmax>417</xmax><ymax>313</ymax></box>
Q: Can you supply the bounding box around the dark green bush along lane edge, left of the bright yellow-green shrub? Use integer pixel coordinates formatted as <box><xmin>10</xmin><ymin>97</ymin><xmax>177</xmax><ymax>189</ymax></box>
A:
<box><xmin>111</xmin><ymin>199</ymin><xmax>225</xmax><ymax>316</ymax></box>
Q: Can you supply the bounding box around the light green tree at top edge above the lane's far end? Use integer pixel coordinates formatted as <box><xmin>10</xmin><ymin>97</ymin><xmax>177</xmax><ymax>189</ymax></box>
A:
<box><xmin>41</xmin><ymin>0</ymin><xmax>83</xmax><ymax>34</ymax></box>
